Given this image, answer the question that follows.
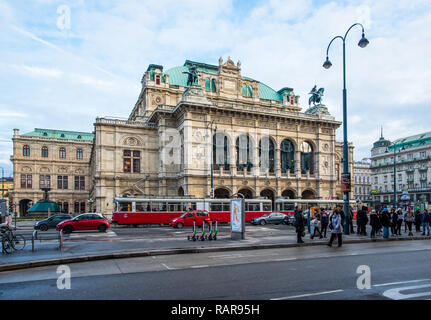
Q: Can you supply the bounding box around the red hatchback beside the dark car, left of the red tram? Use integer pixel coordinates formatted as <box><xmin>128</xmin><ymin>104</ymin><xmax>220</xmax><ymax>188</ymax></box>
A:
<box><xmin>56</xmin><ymin>213</ymin><xmax>109</xmax><ymax>233</ymax></box>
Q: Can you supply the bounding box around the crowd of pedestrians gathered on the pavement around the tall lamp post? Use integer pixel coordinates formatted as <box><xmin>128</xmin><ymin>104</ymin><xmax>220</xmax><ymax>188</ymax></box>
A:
<box><xmin>294</xmin><ymin>206</ymin><xmax>431</xmax><ymax>247</ymax></box>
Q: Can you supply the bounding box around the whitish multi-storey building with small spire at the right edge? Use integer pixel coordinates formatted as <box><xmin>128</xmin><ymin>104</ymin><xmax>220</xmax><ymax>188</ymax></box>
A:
<box><xmin>371</xmin><ymin>132</ymin><xmax>431</xmax><ymax>205</ymax></box>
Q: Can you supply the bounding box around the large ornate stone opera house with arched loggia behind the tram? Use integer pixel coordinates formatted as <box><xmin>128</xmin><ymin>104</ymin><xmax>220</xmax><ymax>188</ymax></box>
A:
<box><xmin>14</xmin><ymin>58</ymin><xmax>353</xmax><ymax>218</ymax></box>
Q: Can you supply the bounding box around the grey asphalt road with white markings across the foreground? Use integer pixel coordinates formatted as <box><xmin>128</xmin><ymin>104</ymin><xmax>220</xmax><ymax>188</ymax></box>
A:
<box><xmin>0</xmin><ymin>241</ymin><xmax>431</xmax><ymax>300</ymax></box>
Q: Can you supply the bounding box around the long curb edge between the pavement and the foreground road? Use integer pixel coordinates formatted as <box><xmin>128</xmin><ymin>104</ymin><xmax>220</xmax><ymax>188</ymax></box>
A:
<box><xmin>0</xmin><ymin>236</ymin><xmax>431</xmax><ymax>272</ymax></box>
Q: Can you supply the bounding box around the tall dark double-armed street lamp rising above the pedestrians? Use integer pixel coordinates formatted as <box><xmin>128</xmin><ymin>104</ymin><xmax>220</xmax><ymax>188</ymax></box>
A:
<box><xmin>323</xmin><ymin>23</ymin><xmax>369</xmax><ymax>235</ymax></box>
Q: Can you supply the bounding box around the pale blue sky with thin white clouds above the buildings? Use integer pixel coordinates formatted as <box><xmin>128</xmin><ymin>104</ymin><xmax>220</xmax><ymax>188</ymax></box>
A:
<box><xmin>0</xmin><ymin>0</ymin><xmax>431</xmax><ymax>176</ymax></box>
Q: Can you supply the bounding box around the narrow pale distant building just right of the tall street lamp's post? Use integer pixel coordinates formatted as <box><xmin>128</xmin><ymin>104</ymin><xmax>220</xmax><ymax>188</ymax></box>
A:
<box><xmin>353</xmin><ymin>161</ymin><xmax>373</xmax><ymax>205</ymax></box>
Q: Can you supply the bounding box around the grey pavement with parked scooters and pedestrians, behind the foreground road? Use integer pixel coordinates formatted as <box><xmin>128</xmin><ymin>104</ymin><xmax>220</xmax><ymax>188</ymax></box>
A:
<box><xmin>0</xmin><ymin>221</ymin><xmax>431</xmax><ymax>271</ymax></box>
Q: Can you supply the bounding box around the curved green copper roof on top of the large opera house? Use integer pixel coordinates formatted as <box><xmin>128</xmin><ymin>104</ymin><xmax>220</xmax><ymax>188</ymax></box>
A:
<box><xmin>164</xmin><ymin>60</ymin><xmax>283</xmax><ymax>101</ymax></box>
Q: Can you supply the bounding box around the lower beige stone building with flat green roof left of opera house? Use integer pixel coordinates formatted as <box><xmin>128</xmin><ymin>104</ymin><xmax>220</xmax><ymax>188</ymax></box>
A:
<box><xmin>11</xmin><ymin>129</ymin><xmax>94</xmax><ymax>216</ymax></box>
